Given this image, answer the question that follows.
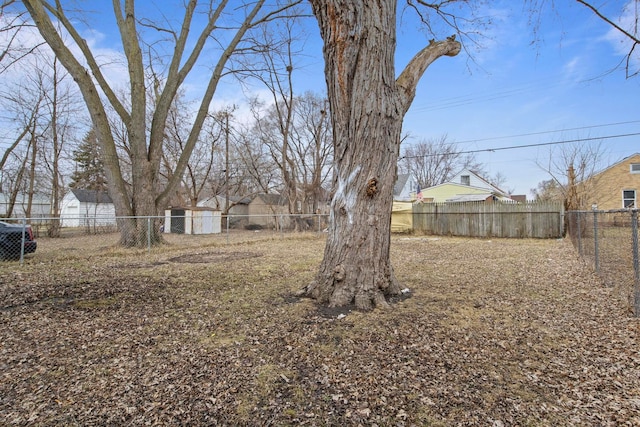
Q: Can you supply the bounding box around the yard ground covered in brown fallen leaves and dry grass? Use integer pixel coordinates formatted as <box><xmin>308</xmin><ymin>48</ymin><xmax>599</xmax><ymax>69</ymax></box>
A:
<box><xmin>0</xmin><ymin>235</ymin><xmax>640</xmax><ymax>426</ymax></box>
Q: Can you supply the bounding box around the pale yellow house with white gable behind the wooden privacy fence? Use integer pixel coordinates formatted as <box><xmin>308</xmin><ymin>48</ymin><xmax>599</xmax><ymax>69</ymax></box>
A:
<box><xmin>418</xmin><ymin>169</ymin><xmax>512</xmax><ymax>203</ymax></box>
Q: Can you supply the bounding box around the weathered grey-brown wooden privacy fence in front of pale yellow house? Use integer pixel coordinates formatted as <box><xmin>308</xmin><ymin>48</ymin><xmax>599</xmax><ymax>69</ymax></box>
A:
<box><xmin>413</xmin><ymin>201</ymin><xmax>564</xmax><ymax>239</ymax></box>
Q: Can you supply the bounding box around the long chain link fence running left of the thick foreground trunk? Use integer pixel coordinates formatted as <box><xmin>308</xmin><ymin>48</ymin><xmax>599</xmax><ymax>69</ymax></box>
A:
<box><xmin>0</xmin><ymin>216</ymin><xmax>329</xmax><ymax>263</ymax></box>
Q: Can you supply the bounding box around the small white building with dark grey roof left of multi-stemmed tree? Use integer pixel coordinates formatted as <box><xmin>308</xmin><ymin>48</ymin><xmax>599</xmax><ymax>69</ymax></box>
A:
<box><xmin>60</xmin><ymin>189</ymin><xmax>116</xmax><ymax>227</ymax></box>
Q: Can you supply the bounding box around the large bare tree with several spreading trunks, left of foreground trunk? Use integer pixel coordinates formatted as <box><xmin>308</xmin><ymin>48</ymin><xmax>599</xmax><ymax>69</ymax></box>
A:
<box><xmin>23</xmin><ymin>0</ymin><xmax>297</xmax><ymax>246</ymax></box>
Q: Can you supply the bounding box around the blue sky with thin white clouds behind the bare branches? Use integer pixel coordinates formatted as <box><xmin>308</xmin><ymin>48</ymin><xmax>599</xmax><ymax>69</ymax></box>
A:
<box><xmin>5</xmin><ymin>0</ymin><xmax>640</xmax><ymax>194</ymax></box>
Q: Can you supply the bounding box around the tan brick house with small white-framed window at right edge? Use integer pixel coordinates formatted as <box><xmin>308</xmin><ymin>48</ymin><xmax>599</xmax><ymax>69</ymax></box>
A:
<box><xmin>577</xmin><ymin>153</ymin><xmax>640</xmax><ymax>210</ymax></box>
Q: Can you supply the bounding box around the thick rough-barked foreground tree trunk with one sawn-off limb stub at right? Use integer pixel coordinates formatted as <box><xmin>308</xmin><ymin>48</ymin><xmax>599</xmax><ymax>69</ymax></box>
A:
<box><xmin>301</xmin><ymin>0</ymin><xmax>460</xmax><ymax>310</ymax></box>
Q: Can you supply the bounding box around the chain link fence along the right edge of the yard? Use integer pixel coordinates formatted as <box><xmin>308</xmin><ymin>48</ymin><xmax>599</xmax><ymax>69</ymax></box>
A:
<box><xmin>566</xmin><ymin>209</ymin><xmax>640</xmax><ymax>317</ymax></box>
